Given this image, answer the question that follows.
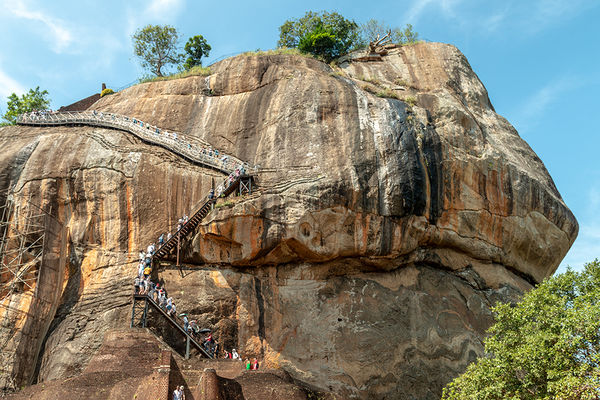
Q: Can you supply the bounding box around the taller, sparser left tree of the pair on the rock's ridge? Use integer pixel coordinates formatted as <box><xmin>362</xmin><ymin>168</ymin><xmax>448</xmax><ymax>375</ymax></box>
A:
<box><xmin>131</xmin><ymin>25</ymin><xmax>183</xmax><ymax>76</ymax></box>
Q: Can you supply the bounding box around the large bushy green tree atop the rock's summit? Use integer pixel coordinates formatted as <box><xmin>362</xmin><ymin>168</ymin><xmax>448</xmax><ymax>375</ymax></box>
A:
<box><xmin>277</xmin><ymin>11</ymin><xmax>359</xmax><ymax>58</ymax></box>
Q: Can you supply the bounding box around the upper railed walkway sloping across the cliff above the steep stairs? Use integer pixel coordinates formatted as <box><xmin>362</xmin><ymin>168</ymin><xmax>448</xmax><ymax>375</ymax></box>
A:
<box><xmin>17</xmin><ymin>110</ymin><xmax>250</xmax><ymax>174</ymax></box>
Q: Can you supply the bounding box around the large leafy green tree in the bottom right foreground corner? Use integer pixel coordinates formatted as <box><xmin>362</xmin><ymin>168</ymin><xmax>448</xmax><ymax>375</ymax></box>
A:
<box><xmin>442</xmin><ymin>260</ymin><xmax>600</xmax><ymax>400</ymax></box>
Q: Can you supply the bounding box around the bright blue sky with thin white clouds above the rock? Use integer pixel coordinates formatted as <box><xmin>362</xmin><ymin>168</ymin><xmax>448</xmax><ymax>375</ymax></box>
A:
<box><xmin>0</xmin><ymin>0</ymin><xmax>600</xmax><ymax>271</ymax></box>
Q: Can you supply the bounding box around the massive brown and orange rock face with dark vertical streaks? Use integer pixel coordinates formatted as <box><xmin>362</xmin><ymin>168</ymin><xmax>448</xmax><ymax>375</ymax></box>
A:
<box><xmin>0</xmin><ymin>43</ymin><xmax>578</xmax><ymax>399</ymax></box>
